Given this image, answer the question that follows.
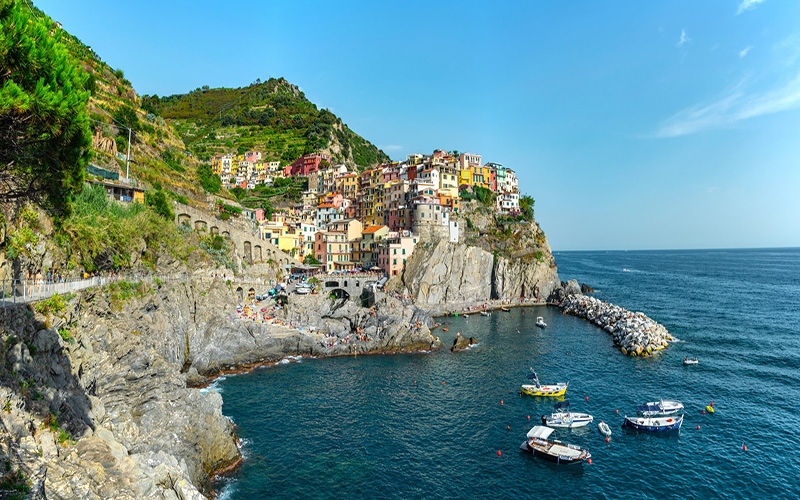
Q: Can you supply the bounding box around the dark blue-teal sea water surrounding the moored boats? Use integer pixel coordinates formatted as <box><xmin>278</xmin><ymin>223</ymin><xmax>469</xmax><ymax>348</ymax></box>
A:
<box><xmin>215</xmin><ymin>249</ymin><xmax>800</xmax><ymax>500</ymax></box>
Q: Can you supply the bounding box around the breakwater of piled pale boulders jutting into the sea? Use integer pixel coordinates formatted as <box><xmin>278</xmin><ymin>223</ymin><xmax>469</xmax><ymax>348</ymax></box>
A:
<box><xmin>559</xmin><ymin>295</ymin><xmax>677</xmax><ymax>356</ymax></box>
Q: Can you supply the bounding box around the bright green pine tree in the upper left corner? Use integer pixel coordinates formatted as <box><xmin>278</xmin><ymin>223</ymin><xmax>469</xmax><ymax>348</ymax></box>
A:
<box><xmin>0</xmin><ymin>0</ymin><xmax>93</xmax><ymax>213</ymax></box>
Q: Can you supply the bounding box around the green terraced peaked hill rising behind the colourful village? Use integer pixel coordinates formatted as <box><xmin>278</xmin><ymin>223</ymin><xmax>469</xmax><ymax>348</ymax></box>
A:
<box><xmin>142</xmin><ymin>78</ymin><xmax>389</xmax><ymax>168</ymax></box>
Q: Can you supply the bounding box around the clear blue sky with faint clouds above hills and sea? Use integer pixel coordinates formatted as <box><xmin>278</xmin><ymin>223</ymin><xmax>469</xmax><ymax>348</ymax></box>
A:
<box><xmin>35</xmin><ymin>0</ymin><xmax>800</xmax><ymax>250</ymax></box>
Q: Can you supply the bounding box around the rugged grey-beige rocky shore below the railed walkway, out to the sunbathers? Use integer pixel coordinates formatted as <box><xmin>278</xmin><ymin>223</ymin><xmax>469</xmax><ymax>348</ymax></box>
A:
<box><xmin>0</xmin><ymin>279</ymin><xmax>441</xmax><ymax>499</ymax></box>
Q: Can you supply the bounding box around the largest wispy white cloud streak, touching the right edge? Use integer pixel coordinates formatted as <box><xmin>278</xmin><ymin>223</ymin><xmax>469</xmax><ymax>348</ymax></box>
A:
<box><xmin>654</xmin><ymin>74</ymin><xmax>800</xmax><ymax>137</ymax></box>
